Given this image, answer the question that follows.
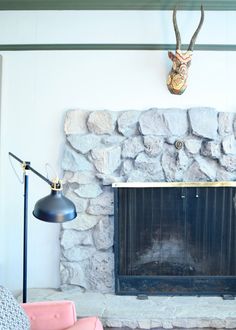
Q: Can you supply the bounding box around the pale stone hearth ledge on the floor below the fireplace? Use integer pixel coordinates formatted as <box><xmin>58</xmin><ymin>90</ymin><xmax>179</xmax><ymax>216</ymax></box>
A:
<box><xmin>18</xmin><ymin>289</ymin><xmax>236</xmax><ymax>329</ymax></box>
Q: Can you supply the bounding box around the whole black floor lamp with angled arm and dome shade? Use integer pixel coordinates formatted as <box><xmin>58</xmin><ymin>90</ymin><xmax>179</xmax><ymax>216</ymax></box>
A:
<box><xmin>9</xmin><ymin>152</ymin><xmax>77</xmax><ymax>303</ymax></box>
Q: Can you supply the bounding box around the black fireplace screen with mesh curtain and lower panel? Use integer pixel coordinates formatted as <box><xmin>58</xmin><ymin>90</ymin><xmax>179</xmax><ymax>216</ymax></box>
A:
<box><xmin>115</xmin><ymin>185</ymin><xmax>236</xmax><ymax>295</ymax></box>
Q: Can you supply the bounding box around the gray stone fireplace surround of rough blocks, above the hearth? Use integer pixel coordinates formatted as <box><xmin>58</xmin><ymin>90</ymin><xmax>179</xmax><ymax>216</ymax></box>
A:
<box><xmin>60</xmin><ymin>108</ymin><xmax>236</xmax><ymax>293</ymax></box>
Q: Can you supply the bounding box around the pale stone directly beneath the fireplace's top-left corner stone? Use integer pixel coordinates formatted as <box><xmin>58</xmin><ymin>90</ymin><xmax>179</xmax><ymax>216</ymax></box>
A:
<box><xmin>67</xmin><ymin>134</ymin><xmax>100</xmax><ymax>154</ymax></box>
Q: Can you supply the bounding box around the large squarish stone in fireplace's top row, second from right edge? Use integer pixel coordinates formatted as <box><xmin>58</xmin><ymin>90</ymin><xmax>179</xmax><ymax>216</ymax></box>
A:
<box><xmin>188</xmin><ymin>108</ymin><xmax>218</xmax><ymax>140</ymax></box>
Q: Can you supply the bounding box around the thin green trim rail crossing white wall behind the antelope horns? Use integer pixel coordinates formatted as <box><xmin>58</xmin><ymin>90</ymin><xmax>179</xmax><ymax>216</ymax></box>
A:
<box><xmin>0</xmin><ymin>44</ymin><xmax>236</xmax><ymax>51</ymax></box>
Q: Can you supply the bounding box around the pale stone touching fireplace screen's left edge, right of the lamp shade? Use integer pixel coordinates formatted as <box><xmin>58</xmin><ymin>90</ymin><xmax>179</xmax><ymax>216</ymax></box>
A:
<box><xmin>87</xmin><ymin>191</ymin><xmax>114</xmax><ymax>215</ymax></box>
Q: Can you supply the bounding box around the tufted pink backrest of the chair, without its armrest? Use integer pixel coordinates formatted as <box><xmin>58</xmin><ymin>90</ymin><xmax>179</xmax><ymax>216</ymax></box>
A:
<box><xmin>22</xmin><ymin>300</ymin><xmax>76</xmax><ymax>330</ymax></box>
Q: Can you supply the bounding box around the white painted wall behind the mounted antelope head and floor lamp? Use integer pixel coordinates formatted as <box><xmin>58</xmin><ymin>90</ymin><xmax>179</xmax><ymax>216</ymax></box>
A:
<box><xmin>0</xmin><ymin>11</ymin><xmax>236</xmax><ymax>290</ymax></box>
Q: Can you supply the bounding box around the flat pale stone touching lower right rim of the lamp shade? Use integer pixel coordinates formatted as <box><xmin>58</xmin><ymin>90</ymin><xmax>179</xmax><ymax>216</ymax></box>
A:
<box><xmin>62</xmin><ymin>213</ymin><xmax>100</xmax><ymax>230</ymax></box>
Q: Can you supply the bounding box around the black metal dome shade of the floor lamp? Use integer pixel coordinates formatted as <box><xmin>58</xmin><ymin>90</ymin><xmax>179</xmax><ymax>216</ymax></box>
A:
<box><xmin>33</xmin><ymin>190</ymin><xmax>77</xmax><ymax>223</ymax></box>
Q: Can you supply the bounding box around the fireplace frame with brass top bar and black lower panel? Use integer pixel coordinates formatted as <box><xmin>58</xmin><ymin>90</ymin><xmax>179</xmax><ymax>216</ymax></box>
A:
<box><xmin>112</xmin><ymin>182</ymin><xmax>236</xmax><ymax>296</ymax></box>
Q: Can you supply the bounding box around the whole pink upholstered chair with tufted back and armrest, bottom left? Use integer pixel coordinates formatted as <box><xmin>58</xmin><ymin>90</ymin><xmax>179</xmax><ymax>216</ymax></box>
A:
<box><xmin>21</xmin><ymin>300</ymin><xmax>103</xmax><ymax>330</ymax></box>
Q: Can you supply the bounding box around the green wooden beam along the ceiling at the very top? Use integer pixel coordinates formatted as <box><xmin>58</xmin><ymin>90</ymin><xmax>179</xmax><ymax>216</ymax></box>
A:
<box><xmin>0</xmin><ymin>0</ymin><xmax>236</xmax><ymax>10</ymax></box>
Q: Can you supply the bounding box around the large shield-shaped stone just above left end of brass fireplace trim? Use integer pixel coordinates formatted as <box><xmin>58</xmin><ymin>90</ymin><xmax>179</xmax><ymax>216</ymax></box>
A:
<box><xmin>91</xmin><ymin>146</ymin><xmax>121</xmax><ymax>174</ymax></box>
